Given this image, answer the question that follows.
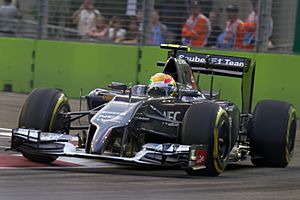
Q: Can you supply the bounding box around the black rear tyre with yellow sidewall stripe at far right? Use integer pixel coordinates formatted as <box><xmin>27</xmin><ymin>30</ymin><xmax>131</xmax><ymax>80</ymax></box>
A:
<box><xmin>249</xmin><ymin>100</ymin><xmax>297</xmax><ymax>167</ymax></box>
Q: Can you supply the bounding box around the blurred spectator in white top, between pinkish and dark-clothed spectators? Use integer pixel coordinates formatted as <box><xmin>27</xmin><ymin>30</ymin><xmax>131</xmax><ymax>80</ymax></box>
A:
<box><xmin>108</xmin><ymin>16</ymin><xmax>126</xmax><ymax>42</ymax></box>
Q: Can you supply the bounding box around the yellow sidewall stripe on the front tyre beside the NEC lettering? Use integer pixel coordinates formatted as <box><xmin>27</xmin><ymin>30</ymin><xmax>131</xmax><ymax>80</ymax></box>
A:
<box><xmin>213</xmin><ymin>107</ymin><xmax>227</xmax><ymax>174</ymax></box>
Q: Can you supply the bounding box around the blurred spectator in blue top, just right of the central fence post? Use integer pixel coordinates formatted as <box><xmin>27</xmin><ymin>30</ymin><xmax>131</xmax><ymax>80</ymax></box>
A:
<box><xmin>150</xmin><ymin>11</ymin><xmax>168</xmax><ymax>45</ymax></box>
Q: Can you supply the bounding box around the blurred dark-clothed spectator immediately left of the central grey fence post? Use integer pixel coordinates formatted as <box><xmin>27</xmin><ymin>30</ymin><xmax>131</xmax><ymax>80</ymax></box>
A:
<box><xmin>122</xmin><ymin>17</ymin><xmax>139</xmax><ymax>44</ymax></box>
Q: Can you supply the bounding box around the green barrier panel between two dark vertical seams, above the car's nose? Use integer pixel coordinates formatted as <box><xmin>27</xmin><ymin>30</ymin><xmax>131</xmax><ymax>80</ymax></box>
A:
<box><xmin>34</xmin><ymin>41</ymin><xmax>137</xmax><ymax>97</ymax></box>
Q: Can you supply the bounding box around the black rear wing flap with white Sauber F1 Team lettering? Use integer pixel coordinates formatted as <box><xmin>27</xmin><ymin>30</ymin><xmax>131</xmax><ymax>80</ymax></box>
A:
<box><xmin>176</xmin><ymin>51</ymin><xmax>251</xmax><ymax>78</ymax></box>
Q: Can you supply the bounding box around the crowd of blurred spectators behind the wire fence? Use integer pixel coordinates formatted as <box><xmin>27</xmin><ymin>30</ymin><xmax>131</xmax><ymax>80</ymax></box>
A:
<box><xmin>0</xmin><ymin>0</ymin><xmax>273</xmax><ymax>49</ymax></box>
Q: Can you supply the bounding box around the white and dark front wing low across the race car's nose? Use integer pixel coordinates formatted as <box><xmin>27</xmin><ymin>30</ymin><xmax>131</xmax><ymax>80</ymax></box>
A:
<box><xmin>11</xmin><ymin>128</ymin><xmax>207</xmax><ymax>170</ymax></box>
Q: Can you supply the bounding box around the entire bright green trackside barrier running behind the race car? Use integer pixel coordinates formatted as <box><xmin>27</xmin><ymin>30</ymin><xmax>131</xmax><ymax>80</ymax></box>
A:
<box><xmin>0</xmin><ymin>38</ymin><xmax>300</xmax><ymax>112</ymax></box>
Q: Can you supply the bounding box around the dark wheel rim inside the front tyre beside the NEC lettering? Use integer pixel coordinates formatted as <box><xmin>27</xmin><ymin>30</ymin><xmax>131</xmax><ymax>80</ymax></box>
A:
<box><xmin>218</xmin><ymin>122</ymin><xmax>229</xmax><ymax>160</ymax></box>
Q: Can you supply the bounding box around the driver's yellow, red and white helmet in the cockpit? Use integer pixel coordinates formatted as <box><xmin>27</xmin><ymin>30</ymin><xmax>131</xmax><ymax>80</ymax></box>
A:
<box><xmin>147</xmin><ymin>73</ymin><xmax>177</xmax><ymax>96</ymax></box>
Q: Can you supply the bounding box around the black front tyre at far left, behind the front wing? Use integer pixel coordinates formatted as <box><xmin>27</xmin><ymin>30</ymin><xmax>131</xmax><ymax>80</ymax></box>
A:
<box><xmin>18</xmin><ymin>88</ymin><xmax>70</xmax><ymax>163</ymax></box>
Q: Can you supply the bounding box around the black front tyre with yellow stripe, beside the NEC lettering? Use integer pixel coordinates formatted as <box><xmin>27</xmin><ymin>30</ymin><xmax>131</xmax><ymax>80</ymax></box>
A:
<box><xmin>181</xmin><ymin>102</ymin><xmax>231</xmax><ymax>176</ymax></box>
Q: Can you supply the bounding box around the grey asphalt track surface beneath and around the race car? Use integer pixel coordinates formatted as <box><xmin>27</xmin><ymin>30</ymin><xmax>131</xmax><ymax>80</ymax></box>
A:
<box><xmin>0</xmin><ymin>93</ymin><xmax>300</xmax><ymax>200</ymax></box>
